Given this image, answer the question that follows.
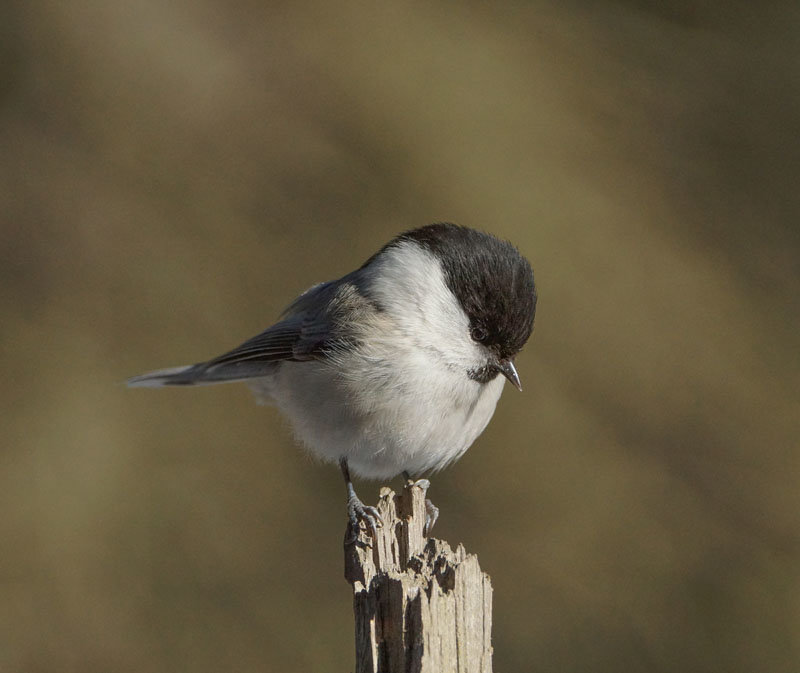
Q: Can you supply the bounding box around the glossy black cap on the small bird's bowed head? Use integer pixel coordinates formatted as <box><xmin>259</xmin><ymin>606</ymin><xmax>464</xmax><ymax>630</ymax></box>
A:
<box><xmin>389</xmin><ymin>222</ymin><xmax>536</xmax><ymax>360</ymax></box>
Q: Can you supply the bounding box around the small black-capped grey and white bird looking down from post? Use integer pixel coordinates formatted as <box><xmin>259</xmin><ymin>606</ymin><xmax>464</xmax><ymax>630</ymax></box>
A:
<box><xmin>128</xmin><ymin>223</ymin><xmax>536</xmax><ymax>535</ymax></box>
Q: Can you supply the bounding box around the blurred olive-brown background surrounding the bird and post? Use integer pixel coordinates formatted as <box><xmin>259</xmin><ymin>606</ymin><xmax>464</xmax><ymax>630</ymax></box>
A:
<box><xmin>0</xmin><ymin>0</ymin><xmax>800</xmax><ymax>673</ymax></box>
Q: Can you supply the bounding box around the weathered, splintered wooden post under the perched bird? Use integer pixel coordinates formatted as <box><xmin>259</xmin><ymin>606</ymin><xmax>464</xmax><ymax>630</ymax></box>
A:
<box><xmin>345</xmin><ymin>486</ymin><xmax>492</xmax><ymax>673</ymax></box>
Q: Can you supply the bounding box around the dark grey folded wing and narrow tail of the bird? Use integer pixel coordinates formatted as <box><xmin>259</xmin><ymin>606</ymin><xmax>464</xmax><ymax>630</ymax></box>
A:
<box><xmin>127</xmin><ymin>282</ymin><xmax>341</xmax><ymax>387</ymax></box>
